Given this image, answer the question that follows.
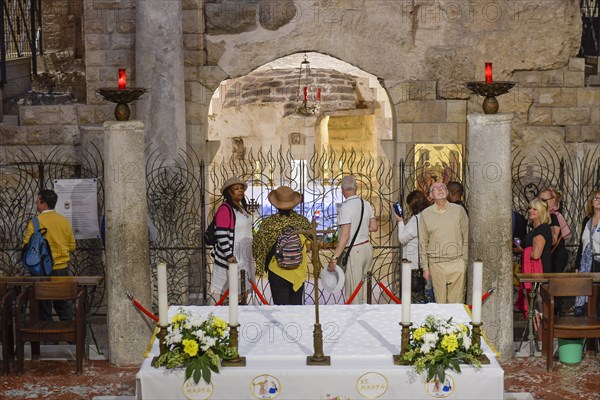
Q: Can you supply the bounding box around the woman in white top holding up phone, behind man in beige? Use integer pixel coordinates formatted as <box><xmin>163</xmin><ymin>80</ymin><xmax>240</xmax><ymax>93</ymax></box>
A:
<box><xmin>394</xmin><ymin>190</ymin><xmax>435</xmax><ymax>303</ymax></box>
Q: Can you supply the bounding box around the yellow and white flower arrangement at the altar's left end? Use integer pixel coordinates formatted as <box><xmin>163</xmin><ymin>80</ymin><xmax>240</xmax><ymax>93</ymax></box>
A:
<box><xmin>155</xmin><ymin>309</ymin><xmax>237</xmax><ymax>383</ymax></box>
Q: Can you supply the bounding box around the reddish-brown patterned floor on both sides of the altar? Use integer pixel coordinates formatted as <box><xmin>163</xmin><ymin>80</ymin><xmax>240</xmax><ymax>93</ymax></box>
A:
<box><xmin>0</xmin><ymin>346</ymin><xmax>600</xmax><ymax>400</ymax></box>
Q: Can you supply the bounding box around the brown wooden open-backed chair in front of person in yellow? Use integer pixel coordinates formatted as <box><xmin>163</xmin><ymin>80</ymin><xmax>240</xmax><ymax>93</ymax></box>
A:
<box><xmin>15</xmin><ymin>280</ymin><xmax>85</xmax><ymax>375</ymax></box>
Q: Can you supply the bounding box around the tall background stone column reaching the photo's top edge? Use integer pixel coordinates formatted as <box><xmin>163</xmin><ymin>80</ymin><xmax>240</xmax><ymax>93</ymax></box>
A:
<box><xmin>135</xmin><ymin>0</ymin><xmax>186</xmax><ymax>160</ymax></box>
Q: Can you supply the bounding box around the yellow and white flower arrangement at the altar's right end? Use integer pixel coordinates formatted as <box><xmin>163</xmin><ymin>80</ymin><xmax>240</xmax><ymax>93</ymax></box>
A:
<box><xmin>403</xmin><ymin>315</ymin><xmax>483</xmax><ymax>382</ymax></box>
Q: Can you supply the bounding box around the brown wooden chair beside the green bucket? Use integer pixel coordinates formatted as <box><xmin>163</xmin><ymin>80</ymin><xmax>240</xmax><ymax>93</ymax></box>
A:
<box><xmin>540</xmin><ymin>274</ymin><xmax>600</xmax><ymax>371</ymax></box>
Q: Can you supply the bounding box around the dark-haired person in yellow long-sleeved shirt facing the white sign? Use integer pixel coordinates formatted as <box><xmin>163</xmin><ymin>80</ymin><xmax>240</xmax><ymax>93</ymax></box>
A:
<box><xmin>23</xmin><ymin>189</ymin><xmax>75</xmax><ymax>321</ymax></box>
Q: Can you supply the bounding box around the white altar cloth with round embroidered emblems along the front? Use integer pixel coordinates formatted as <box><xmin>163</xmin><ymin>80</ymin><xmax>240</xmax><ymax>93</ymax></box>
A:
<box><xmin>137</xmin><ymin>304</ymin><xmax>504</xmax><ymax>400</ymax></box>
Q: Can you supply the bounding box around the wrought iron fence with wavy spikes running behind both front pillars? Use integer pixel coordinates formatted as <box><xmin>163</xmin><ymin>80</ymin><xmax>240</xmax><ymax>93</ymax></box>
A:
<box><xmin>0</xmin><ymin>145</ymin><xmax>600</xmax><ymax>314</ymax></box>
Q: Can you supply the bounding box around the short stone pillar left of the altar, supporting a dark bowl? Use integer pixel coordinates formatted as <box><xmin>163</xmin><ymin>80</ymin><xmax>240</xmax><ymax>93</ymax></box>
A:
<box><xmin>104</xmin><ymin>121</ymin><xmax>153</xmax><ymax>366</ymax></box>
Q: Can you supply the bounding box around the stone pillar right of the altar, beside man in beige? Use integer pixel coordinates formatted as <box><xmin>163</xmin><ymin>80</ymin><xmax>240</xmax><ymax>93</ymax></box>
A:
<box><xmin>467</xmin><ymin>114</ymin><xmax>514</xmax><ymax>359</ymax></box>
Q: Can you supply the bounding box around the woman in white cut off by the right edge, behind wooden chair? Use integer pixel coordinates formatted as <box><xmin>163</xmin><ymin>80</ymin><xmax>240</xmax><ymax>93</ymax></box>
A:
<box><xmin>574</xmin><ymin>190</ymin><xmax>600</xmax><ymax>316</ymax></box>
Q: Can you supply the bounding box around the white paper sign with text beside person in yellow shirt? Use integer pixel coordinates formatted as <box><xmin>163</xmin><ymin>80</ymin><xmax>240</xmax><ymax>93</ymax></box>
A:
<box><xmin>54</xmin><ymin>179</ymin><xmax>100</xmax><ymax>239</ymax></box>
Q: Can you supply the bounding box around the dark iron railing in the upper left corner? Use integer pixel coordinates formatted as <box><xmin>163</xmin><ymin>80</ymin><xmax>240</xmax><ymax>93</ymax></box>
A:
<box><xmin>0</xmin><ymin>0</ymin><xmax>42</xmax><ymax>83</ymax></box>
